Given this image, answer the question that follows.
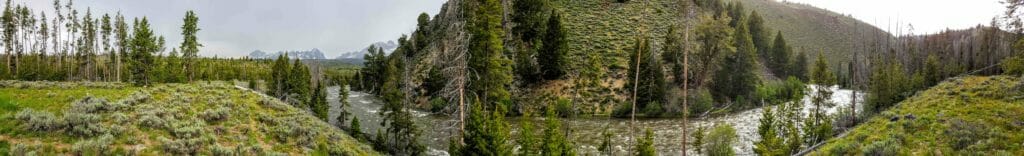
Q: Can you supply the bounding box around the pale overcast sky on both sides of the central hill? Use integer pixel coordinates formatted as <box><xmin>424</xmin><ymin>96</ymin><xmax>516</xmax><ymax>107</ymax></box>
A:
<box><xmin>15</xmin><ymin>0</ymin><xmax>1004</xmax><ymax>57</ymax></box>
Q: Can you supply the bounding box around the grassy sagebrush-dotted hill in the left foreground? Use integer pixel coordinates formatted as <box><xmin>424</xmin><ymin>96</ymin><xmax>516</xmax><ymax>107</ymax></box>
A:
<box><xmin>0</xmin><ymin>81</ymin><xmax>376</xmax><ymax>155</ymax></box>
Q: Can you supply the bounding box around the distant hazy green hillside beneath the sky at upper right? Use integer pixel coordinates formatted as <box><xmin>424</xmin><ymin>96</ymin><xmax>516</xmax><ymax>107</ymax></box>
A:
<box><xmin>731</xmin><ymin>0</ymin><xmax>891</xmax><ymax>66</ymax></box>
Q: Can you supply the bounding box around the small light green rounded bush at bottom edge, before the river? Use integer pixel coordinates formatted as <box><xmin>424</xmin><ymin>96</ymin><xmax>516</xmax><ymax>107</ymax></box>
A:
<box><xmin>705</xmin><ymin>123</ymin><xmax>738</xmax><ymax>156</ymax></box>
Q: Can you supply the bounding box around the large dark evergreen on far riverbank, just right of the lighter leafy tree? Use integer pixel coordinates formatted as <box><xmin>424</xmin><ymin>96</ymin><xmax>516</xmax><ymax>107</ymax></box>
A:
<box><xmin>711</xmin><ymin>21</ymin><xmax>761</xmax><ymax>105</ymax></box>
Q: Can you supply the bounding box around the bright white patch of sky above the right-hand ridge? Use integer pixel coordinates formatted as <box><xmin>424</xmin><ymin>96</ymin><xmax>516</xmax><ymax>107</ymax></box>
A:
<box><xmin>787</xmin><ymin>0</ymin><xmax>1006</xmax><ymax>34</ymax></box>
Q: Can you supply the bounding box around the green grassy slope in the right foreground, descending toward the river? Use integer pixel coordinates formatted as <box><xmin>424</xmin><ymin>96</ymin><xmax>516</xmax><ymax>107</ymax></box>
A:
<box><xmin>812</xmin><ymin>76</ymin><xmax>1024</xmax><ymax>155</ymax></box>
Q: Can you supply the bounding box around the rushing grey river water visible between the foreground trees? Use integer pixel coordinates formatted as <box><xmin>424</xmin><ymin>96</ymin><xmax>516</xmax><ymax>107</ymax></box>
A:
<box><xmin>328</xmin><ymin>85</ymin><xmax>863</xmax><ymax>155</ymax></box>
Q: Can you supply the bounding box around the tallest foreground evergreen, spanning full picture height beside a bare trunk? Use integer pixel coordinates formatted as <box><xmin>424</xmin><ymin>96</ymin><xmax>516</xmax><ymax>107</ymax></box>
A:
<box><xmin>452</xmin><ymin>0</ymin><xmax>512</xmax><ymax>155</ymax></box>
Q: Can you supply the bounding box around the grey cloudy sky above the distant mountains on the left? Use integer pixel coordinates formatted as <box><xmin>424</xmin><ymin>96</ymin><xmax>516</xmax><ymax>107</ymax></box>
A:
<box><xmin>14</xmin><ymin>0</ymin><xmax>445</xmax><ymax>57</ymax></box>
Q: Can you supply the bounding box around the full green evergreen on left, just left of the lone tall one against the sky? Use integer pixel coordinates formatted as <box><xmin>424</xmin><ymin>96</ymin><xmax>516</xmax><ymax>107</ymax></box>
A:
<box><xmin>130</xmin><ymin>17</ymin><xmax>160</xmax><ymax>85</ymax></box>
